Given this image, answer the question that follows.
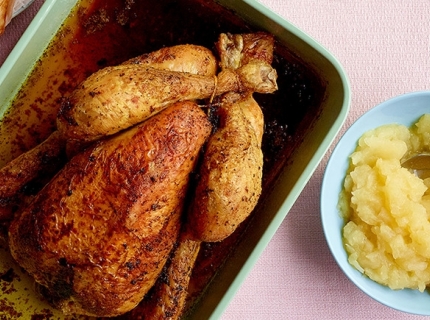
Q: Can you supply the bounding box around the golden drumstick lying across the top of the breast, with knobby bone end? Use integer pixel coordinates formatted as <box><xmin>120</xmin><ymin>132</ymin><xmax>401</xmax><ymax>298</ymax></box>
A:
<box><xmin>57</xmin><ymin>56</ymin><xmax>277</xmax><ymax>141</ymax></box>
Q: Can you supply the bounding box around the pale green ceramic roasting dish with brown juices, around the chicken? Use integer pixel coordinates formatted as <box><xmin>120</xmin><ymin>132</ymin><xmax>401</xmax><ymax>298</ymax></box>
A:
<box><xmin>0</xmin><ymin>0</ymin><xmax>350</xmax><ymax>319</ymax></box>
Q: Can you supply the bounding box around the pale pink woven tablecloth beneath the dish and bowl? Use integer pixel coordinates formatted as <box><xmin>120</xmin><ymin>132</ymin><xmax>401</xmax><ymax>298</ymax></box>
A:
<box><xmin>0</xmin><ymin>0</ymin><xmax>430</xmax><ymax>320</ymax></box>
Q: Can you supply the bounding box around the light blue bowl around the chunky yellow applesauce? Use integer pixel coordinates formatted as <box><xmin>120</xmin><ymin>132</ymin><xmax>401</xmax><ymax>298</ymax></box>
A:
<box><xmin>321</xmin><ymin>91</ymin><xmax>430</xmax><ymax>315</ymax></box>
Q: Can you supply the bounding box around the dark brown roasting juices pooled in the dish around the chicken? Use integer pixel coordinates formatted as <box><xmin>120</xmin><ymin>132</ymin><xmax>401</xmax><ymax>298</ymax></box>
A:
<box><xmin>0</xmin><ymin>0</ymin><xmax>324</xmax><ymax>319</ymax></box>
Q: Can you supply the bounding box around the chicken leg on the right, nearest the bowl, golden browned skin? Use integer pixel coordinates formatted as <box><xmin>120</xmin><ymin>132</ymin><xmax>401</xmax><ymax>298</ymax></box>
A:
<box><xmin>188</xmin><ymin>93</ymin><xmax>264</xmax><ymax>242</ymax></box>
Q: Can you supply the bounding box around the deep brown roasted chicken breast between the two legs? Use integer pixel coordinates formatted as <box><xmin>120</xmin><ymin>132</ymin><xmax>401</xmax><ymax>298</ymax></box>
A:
<box><xmin>9</xmin><ymin>102</ymin><xmax>211</xmax><ymax>316</ymax></box>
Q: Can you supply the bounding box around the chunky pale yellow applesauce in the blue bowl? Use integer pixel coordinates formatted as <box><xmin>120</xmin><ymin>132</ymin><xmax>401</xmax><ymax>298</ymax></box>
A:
<box><xmin>339</xmin><ymin>114</ymin><xmax>430</xmax><ymax>292</ymax></box>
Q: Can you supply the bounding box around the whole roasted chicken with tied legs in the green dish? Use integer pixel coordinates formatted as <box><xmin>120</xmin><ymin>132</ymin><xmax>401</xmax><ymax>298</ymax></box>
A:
<box><xmin>0</xmin><ymin>33</ymin><xmax>277</xmax><ymax>318</ymax></box>
